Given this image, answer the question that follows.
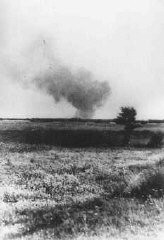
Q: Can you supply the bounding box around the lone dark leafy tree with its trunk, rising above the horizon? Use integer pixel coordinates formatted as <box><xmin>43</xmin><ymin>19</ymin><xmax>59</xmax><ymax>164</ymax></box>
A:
<box><xmin>116</xmin><ymin>107</ymin><xmax>137</xmax><ymax>145</ymax></box>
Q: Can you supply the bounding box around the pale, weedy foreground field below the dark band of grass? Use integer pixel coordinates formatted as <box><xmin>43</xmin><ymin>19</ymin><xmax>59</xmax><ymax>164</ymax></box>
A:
<box><xmin>0</xmin><ymin>143</ymin><xmax>164</xmax><ymax>240</ymax></box>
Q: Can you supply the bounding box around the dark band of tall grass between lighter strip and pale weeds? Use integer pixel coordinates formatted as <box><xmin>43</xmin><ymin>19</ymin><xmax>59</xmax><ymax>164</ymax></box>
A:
<box><xmin>0</xmin><ymin>128</ymin><xmax>159</xmax><ymax>148</ymax></box>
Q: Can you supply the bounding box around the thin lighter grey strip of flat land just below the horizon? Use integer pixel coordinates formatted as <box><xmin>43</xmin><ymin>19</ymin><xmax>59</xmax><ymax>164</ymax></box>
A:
<box><xmin>0</xmin><ymin>119</ymin><xmax>164</xmax><ymax>131</ymax></box>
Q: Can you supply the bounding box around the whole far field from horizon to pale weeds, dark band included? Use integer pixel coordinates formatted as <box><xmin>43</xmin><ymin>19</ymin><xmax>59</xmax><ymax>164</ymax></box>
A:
<box><xmin>0</xmin><ymin>119</ymin><xmax>164</xmax><ymax>147</ymax></box>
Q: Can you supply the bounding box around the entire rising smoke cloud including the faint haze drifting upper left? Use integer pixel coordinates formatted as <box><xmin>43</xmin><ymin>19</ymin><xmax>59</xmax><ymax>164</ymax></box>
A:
<box><xmin>1</xmin><ymin>35</ymin><xmax>110</xmax><ymax>118</ymax></box>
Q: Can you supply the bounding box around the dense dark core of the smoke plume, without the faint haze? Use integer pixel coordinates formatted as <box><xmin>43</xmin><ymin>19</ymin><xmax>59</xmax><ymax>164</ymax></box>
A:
<box><xmin>33</xmin><ymin>66</ymin><xmax>110</xmax><ymax>118</ymax></box>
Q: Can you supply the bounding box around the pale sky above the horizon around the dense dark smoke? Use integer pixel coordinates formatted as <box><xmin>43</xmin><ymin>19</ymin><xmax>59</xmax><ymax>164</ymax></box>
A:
<box><xmin>0</xmin><ymin>0</ymin><xmax>164</xmax><ymax>119</ymax></box>
